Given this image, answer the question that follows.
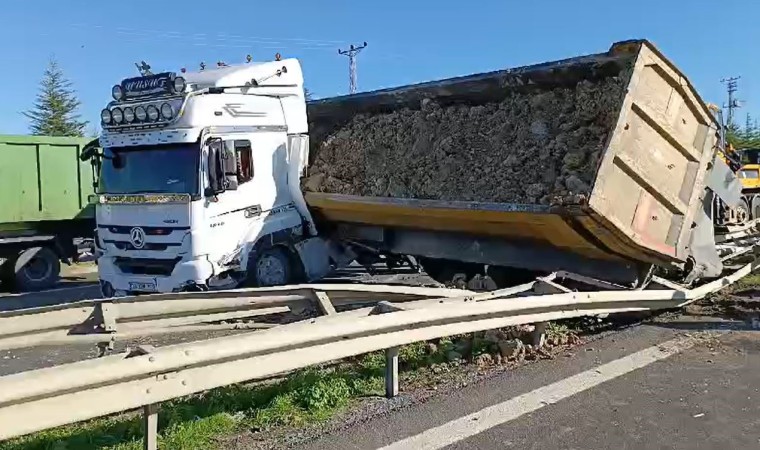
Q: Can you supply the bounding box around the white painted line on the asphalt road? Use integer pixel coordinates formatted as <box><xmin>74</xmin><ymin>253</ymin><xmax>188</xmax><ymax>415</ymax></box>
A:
<box><xmin>380</xmin><ymin>338</ymin><xmax>694</xmax><ymax>450</ymax></box>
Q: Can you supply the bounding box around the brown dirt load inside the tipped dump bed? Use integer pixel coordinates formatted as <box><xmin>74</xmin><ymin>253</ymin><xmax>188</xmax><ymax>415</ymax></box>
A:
<box><xmin>302</xmin><ymin>77</ymin><xmax>627</xmax><ymax>205</ymax></box>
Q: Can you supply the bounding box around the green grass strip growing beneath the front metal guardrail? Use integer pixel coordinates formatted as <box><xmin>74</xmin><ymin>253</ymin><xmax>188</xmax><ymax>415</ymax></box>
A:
<box><xmin>0</xmin><ymin>366</ymin><xmax>384</xmax><ymax>450</ymax></box>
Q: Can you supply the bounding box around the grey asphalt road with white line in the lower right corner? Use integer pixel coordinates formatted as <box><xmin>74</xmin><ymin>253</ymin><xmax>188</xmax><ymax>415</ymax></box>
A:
<box><xmin>301</xmin><ymin>319</ymin><xmax>760</xmax><ymax>450</ymax></box>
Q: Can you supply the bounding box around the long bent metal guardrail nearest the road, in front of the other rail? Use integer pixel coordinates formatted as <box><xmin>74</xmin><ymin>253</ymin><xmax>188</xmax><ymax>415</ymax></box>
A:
<box><xmin>0</xmin><ymin>260</ymin><xmax>760</xmax><ymax>448</ymax></box>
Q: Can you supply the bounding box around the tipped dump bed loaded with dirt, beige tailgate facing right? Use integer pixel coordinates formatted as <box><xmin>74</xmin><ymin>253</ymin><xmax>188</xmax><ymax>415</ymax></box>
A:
<box><xmin>303</xmin><ymin>41</ymin><xmax>717</xmax><ymax>264</ymax></box>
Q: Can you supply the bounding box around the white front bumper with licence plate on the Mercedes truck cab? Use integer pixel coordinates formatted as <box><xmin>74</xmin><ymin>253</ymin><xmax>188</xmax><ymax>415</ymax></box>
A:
<box><xmin>98</xmin><ymin>256</ymin><xmax>215</xmax><ymax>298</ymax></box>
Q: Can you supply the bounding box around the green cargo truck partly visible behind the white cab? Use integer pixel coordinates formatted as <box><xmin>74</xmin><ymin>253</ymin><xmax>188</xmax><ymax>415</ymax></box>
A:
<box><xmin>0</xmin><ymin>135</ymin><xmax>95</xmax><ymax>292</ymax></box>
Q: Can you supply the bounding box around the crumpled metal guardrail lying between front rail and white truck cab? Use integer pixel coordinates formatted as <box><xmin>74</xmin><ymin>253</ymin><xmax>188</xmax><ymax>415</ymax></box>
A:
<box><xmin>0</xmin><ymin>284</ymin><xmax>472</xmax><ymax>350</ymax></box>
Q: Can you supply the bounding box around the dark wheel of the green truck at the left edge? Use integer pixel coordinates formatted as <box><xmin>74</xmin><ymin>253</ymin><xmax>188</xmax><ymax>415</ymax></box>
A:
<box><xmin>3</xmin><ymin>247</ymin><xmax>61</xmax><ymax>292</ymax></box>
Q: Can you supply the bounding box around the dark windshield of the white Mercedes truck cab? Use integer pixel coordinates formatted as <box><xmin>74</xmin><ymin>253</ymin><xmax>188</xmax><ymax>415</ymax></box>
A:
<box><xmin>98</xmin><ymin>143</ymin><xmax>201</xmax><ymax>195</ymax></box>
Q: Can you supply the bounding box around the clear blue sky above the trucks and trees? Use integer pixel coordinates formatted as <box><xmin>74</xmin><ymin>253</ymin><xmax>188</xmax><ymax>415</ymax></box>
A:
<box><xmin>0</xmin><ymin>0</ymin><xmax>760</xmax><ymax>134</ymax></box>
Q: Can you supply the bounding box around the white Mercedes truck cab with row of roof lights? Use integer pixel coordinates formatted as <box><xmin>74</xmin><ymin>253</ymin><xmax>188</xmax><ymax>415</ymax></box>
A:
<box><xmin>83</xmin><ymin>58</ymin><xmax>330</xmax><ymax>297</ymax></box>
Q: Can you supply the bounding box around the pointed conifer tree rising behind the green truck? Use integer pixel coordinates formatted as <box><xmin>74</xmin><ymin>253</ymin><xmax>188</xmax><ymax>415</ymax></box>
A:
<box><xmin>22</xmin><ymin>59</ymin><xmax>87</xmax><ymax>136</ymax></box>
